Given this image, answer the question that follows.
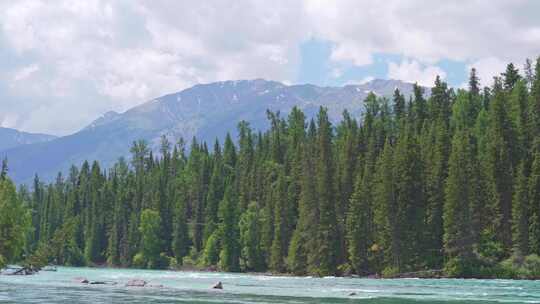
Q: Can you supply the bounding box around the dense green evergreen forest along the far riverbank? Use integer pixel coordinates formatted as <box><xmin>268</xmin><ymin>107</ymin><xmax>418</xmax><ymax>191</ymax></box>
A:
<box><xmin>0</xmin><ymin>58</ymin><xmax>540</xmax><ymax>278</ymax></box>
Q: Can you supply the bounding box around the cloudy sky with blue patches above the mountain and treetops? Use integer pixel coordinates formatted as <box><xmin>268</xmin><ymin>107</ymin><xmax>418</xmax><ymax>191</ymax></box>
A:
<box><xmin>0</xmin><ymin>0</ymin><xmax>540</xmax><ymax>135</ymax></box>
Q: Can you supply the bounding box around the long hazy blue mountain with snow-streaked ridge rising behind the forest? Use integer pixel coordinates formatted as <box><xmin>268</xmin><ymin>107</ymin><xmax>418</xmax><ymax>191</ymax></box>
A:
<box><xmin>0</xmin><ymin>79</ymin><xmax>413</xmax><ymax>183</ymax></box>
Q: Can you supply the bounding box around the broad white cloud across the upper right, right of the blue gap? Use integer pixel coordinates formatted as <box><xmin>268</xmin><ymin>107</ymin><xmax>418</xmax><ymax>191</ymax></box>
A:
<box><xmin>305</xmin><ymin>0</ymin><xmax>540</xmax><ymax>65</ymax></box>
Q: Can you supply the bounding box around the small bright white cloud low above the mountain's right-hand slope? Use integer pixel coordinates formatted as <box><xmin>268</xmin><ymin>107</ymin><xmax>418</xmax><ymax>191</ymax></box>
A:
<box><xmin>388</xmin><ymin>59</ymin><xmax>446</xmax><ymax>86</ymax></box>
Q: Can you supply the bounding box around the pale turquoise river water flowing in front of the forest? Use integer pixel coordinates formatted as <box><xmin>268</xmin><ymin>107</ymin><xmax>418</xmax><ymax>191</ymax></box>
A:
<box><xmin>0</xmin><ymin>267</ymin><xmax>540</xmax><ymax>304</ymax></box>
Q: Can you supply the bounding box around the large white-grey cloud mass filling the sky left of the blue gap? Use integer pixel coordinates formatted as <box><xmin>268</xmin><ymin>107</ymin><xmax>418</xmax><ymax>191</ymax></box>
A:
<box><xmin>0</xmin><ymin>0</ymin><xmax>309</xmax><ymax>134</ymax></box>
